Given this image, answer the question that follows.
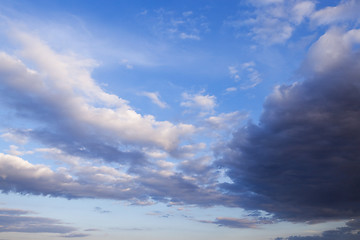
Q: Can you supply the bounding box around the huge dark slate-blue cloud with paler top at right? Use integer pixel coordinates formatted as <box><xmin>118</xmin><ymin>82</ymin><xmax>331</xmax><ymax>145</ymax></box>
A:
<box><xmin>219</xmin><ymin>29</ymin><xmax>360</xmax><ymax>221</ymax></box>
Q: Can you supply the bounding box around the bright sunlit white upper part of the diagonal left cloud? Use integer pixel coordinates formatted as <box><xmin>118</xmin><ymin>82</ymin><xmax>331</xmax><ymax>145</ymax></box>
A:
<box><xmin>0</xmin><ymin>32</ymin><xmax>195</xmax><ymax>150</ymax></box>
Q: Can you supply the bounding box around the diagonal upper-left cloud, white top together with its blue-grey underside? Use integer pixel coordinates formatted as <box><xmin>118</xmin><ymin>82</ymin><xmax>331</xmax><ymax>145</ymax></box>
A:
<box><xmin>0</xmin><ymin>30</ymin><xmax>195</xmax><ymax>161</ymax></box>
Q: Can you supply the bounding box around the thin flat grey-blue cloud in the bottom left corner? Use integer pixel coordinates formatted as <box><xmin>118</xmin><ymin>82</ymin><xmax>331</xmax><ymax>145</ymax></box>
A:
<box><xmin>0</xmin><ymin>209</ymin><xmax>77</xmax><ymax>233</ymax></box>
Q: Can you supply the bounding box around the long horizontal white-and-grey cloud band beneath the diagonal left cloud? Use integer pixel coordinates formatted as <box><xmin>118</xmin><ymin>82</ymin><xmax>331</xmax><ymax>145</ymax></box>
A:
<box><xmin>0</xmin><ymin>153</ymin><xmax>229</xmax><ymax>206</ymax></box>
